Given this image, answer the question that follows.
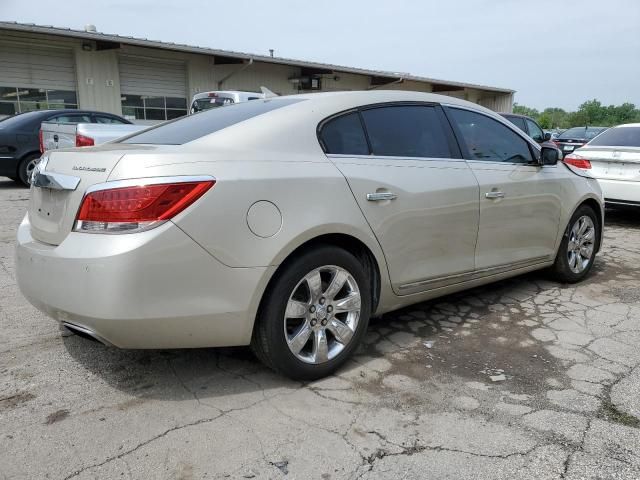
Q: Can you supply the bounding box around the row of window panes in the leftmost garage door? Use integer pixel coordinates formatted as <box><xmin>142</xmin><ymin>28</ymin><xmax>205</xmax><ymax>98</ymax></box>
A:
<box><xmin>0</xmin><ymin>86</ymin><xmax>78</xmax><ymax>115</ymax></box>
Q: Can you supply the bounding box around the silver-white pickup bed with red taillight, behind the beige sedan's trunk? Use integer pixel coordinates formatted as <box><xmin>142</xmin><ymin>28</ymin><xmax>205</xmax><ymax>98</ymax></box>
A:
<box><xmin>40</xmin><ymin>122</ymin><xmax>149</xmax><ymax>153</ymax></box>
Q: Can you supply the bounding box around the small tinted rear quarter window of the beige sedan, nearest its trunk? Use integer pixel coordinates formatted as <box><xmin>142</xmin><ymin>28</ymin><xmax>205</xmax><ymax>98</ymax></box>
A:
<box><xmin>320</xmin><ymin>112</ymin><xmax>369</xmax><ymax>155</ymax></box>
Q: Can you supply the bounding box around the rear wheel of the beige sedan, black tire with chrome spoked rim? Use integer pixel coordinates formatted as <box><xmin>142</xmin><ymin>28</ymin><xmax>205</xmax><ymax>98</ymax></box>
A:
<box><xmin>251</xmin><ymin>246</ymin><xmax>371</xmax><ymax>380</ymax></box>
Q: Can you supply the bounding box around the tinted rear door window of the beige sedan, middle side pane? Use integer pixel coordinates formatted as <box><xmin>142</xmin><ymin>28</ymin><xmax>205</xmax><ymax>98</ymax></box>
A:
<box><xmin>362</xmin><ymin>105</ymin><xmax>451</xmax><ymax>158</ymax></box>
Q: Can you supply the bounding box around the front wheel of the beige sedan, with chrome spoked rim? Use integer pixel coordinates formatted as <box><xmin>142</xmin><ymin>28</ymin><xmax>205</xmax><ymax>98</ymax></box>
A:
<box><xmin>551</xmin><ymin>205</ymin><xmax>601</xmax><ymax>283</ymax></box>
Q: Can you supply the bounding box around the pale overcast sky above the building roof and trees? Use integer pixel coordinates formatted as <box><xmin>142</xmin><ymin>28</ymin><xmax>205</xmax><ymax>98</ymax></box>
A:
<box><xmin>0</xmin><ymin>0</ymin><xmax>640</xmax><ymax>109</ymax></box>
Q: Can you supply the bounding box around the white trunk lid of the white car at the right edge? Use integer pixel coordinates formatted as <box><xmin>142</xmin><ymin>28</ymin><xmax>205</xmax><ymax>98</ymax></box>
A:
<box><xmin>575</xmin><ymin>145</ymin><xmax>640</xmax><ymax>182</ymax></box>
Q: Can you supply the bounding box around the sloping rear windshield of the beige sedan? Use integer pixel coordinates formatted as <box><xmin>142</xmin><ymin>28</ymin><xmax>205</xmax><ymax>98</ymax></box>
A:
<box><xmin>124</xmin><ymin>98</ymin><xmax>302</xmax><ymax>145</ymax></box>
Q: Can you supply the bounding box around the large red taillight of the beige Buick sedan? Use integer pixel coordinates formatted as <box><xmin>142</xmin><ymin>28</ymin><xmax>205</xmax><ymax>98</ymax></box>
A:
<box><xmin>74</xmin><ymin>177</ymin><xmax>216</xmax><ymax>233</ymax></box>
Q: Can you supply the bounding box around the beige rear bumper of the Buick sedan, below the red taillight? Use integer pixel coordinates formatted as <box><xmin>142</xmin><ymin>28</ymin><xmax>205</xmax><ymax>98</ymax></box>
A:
<box><xmin>16</xmin><ymin>217</ymin><xmax>268</xmax><ymax>348</ymax></box>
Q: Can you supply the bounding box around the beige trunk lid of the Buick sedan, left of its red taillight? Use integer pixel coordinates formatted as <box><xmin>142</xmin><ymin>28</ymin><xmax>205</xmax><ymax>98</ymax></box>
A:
<box><xmin>28</xmin><ymin>144</ymin><xmax>156</xmax><ymax>245</ymax></box>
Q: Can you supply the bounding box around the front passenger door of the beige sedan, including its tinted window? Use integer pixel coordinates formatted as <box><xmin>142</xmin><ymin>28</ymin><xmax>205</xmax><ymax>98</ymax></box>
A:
<box><xmin>447</xmin><ymin>107</ymin><xmax>564</xmax><ymax>273</ymax></box>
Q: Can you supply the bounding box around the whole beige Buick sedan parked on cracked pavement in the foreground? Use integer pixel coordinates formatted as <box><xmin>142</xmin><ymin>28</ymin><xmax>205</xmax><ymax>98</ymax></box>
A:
<box><xmin>17</xmin><ymin>91</ymin><xmax>603</xmax><ymax>379</ymax></box>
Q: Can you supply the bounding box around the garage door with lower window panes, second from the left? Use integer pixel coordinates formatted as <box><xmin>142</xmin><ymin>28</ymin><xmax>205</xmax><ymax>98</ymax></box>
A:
<box><xmin>119</xmin><ymin>55</ymin><xmax>187</xmax><ymax>121</ymax></box>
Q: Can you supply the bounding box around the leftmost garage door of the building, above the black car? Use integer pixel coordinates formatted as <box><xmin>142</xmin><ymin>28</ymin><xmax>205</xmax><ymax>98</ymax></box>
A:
<box><xmin>0</xmin><ymin>43</ymin><xmax>78</xmax><ymax>115</ymax></box>
